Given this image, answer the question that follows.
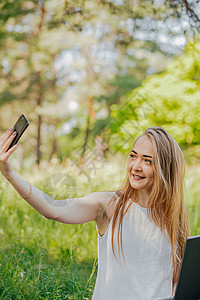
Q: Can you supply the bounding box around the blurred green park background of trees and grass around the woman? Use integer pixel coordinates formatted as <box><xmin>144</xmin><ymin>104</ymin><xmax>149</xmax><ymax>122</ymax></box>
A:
<box><xmin>0</xmin><ymin>0</ymin><xmax>200</xmax><ymax>299</ymax></box>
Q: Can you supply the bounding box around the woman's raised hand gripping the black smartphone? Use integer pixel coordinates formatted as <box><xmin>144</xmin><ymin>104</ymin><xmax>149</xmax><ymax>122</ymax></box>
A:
<box><xmin>0</xmin><ymin>128</ymin><xmax>19</xmax><ymax>177</ymax></box>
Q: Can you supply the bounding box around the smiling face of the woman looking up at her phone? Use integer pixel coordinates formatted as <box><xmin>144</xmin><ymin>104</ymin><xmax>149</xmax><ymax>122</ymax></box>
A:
<box><xmin>128</xmin><ymin>136</ymin><xmax>153</xmax><ymax>192</ymax></box>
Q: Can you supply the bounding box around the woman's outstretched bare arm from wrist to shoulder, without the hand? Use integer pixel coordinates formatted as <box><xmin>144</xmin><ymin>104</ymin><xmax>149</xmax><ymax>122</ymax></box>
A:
<box><xmin>6</xmin><ymin>171</ymin><xmax>110</xmax><ymax>224</ymax></box>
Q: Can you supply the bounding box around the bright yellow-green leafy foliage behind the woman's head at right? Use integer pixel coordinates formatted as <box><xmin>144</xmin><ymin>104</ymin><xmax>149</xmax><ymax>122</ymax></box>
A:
<box><xmin>111</xmin><ymin>43</ymin><xmax>200</xmax><ymax>162</ymax></box>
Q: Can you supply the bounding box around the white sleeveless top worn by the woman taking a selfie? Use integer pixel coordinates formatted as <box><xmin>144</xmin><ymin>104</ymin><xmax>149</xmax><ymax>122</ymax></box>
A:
<box><xmin>92</xmin><ymin>195</ymin><xmax>172</xmax><ymax>300</ymax></box>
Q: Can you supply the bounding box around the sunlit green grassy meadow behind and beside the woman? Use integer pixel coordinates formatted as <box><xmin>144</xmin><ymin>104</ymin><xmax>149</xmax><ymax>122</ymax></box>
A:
<box><xmin>0</xmin><ymin>155</ymin><xmax>200</xmax><ymax>299</ymax></box>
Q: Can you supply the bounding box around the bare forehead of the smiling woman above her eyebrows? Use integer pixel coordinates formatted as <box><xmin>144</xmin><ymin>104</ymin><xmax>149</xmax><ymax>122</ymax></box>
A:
<box><xmin>133</xmin><ymin>136</ymin><xmax>153</xmax><ymax>156</ymax></box>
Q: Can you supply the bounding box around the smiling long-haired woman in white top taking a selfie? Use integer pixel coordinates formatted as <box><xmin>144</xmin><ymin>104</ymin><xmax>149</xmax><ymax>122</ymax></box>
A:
<box><xmin>0</xmin><ymin>127</ymin><xmax>190</xmax><ymax>300</ymax></box>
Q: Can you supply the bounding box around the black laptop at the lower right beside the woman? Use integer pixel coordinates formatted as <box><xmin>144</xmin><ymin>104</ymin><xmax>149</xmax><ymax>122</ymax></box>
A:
<box><xmin>159</xmin><ymin>235</ymin><xmax>200</xmax><ymax>300</ymax></box>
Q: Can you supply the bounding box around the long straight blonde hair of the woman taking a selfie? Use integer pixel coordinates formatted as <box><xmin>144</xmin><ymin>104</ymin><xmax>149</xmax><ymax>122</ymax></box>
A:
<box><xmin>109</xmin><ymin>126</ymin><xmax>190</xmax><ymax>279</ymax></box>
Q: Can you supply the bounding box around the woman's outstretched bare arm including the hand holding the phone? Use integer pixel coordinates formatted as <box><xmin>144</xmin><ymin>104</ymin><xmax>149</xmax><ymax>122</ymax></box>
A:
<box><xmin>0</xmin><ymin>130</ymin><xmax>113</xmax><ymax>224</ymax></box>
